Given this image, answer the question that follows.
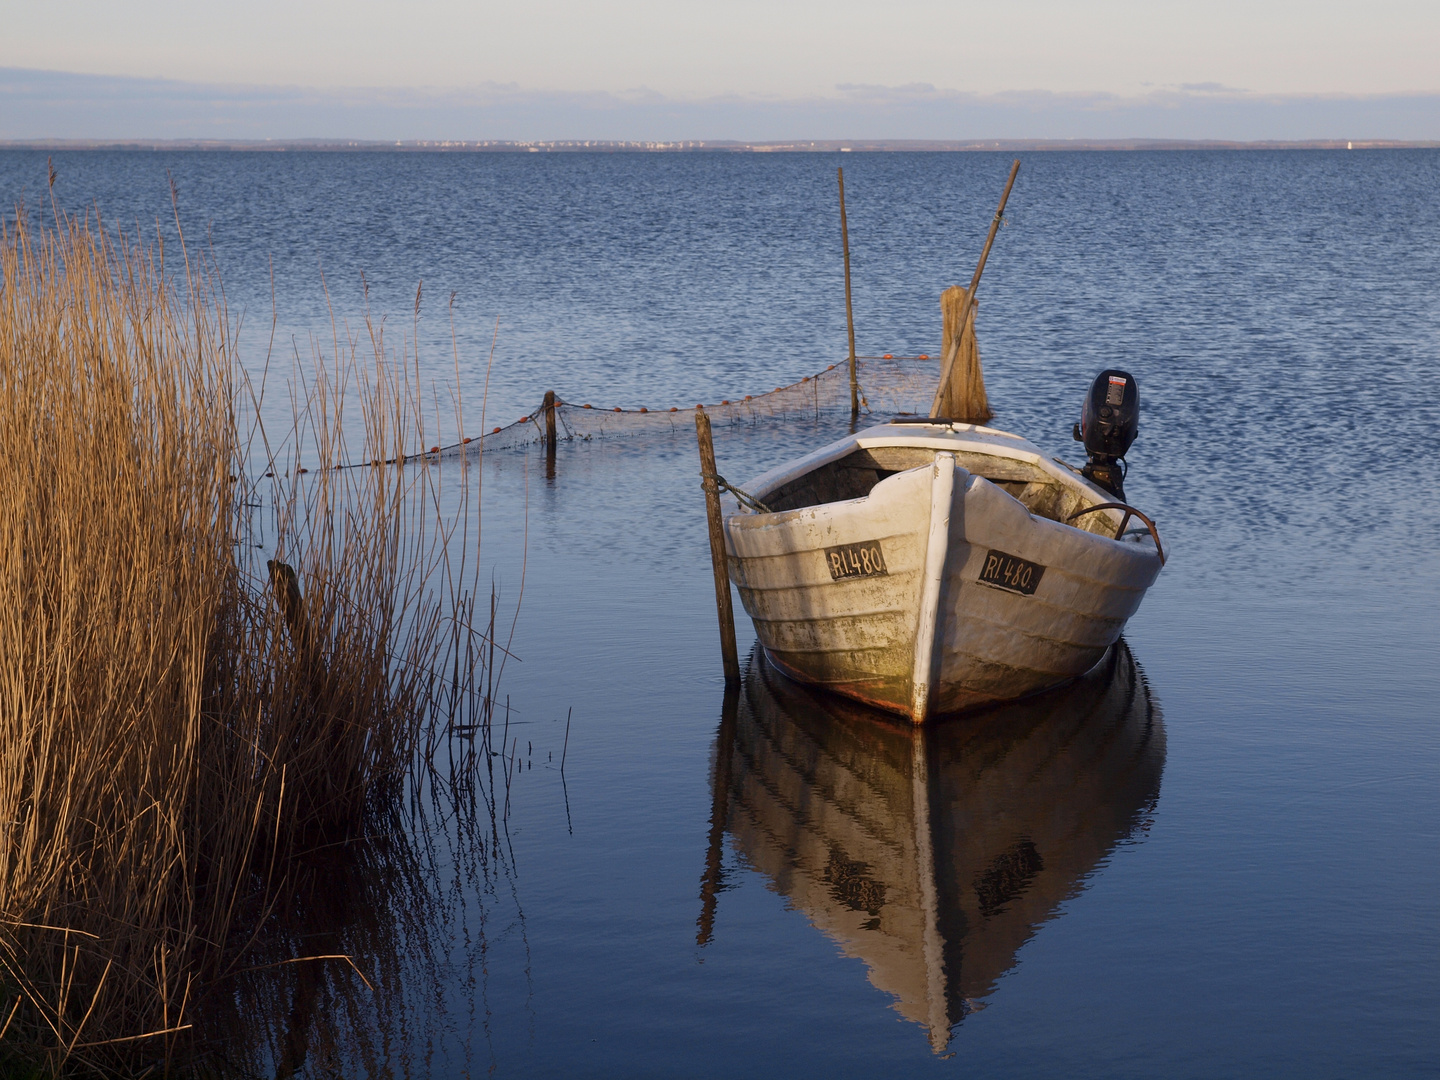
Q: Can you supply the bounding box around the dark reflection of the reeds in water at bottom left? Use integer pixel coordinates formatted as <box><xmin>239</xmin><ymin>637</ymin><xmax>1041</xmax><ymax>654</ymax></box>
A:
<box><xmin>197</xmin><ymin>776</ymin><xmax>524</xmax><ymax>1080</ymax></box>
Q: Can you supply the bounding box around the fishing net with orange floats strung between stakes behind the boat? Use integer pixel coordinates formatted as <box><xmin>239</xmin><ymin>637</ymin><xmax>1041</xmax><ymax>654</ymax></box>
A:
<box><xmin>431</xmin><ymin>354</ymin><xmax>940</xmax><ymax>459</ymax></box>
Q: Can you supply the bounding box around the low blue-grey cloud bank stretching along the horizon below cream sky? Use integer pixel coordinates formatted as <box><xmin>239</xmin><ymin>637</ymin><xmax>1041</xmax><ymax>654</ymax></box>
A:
<box><xmin>0</xmin><ymin>68</ymin><xmax>1440</xmax><ymax>141</ymax></box>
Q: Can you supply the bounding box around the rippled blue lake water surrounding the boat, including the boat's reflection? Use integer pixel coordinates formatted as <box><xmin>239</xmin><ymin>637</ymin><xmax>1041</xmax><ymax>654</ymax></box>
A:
<box><xmin>0</xmin><ymin>151</ymin><xmax>1440</xmax><ymax>1077</ymax></box>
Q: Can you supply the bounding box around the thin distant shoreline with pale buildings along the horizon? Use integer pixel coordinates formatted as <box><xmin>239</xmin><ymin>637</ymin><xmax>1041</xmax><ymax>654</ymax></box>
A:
<box><xmin>0</xmin><ymin>138</ymin><xmax>1440</xmax><ymax>154</ymax></box>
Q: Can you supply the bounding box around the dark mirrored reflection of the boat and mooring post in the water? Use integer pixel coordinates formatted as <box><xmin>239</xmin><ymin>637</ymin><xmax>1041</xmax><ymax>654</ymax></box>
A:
<box><xmin>698</xmin><ymin>641</ymin><xmax>1165</xmax><ymax>1053</ymax></box>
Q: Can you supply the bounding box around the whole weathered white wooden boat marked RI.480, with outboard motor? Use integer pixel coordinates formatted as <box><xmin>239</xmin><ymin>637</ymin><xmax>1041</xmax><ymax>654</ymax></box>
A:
<box><xmin>724</xmin><ymin>417</ymin><xmax>1164</xmax><ymax>723</ymax></box>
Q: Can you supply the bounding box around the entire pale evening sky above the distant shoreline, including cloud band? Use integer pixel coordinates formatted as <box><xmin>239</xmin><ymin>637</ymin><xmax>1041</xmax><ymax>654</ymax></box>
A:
<box><xmin>0</xmin><ymin>0</ymin><xmax>1440</xmax><ymax>140</ymax></box>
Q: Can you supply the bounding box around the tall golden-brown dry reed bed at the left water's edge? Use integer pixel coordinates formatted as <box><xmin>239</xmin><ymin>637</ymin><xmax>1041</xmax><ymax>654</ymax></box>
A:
<box><xmin>0</xmin><ymin>213</ymin><xmax>494</xmax><ymax>1074</ymax></box>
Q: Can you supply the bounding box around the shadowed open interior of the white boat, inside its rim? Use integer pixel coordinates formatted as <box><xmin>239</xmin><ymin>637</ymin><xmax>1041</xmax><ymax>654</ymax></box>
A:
<box><xmin>760</xmin><ymin>446</ymin><xmax>1115</xmax><ymax>536</ymax></box>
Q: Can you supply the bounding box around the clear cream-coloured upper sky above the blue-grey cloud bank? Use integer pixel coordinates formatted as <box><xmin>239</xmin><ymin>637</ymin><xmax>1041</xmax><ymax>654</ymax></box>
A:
<box><xmin>0</xmin><ymin>0</ymin><xmax>1440</xmax><ymax>98</ymax></box>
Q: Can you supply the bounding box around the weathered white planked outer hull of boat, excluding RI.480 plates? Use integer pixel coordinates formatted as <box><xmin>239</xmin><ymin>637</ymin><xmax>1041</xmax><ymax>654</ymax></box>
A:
<box><xmin>726</xmin><ymin>426</ymin><xmax>1161</xmax><ymax>723</ymax></box>
